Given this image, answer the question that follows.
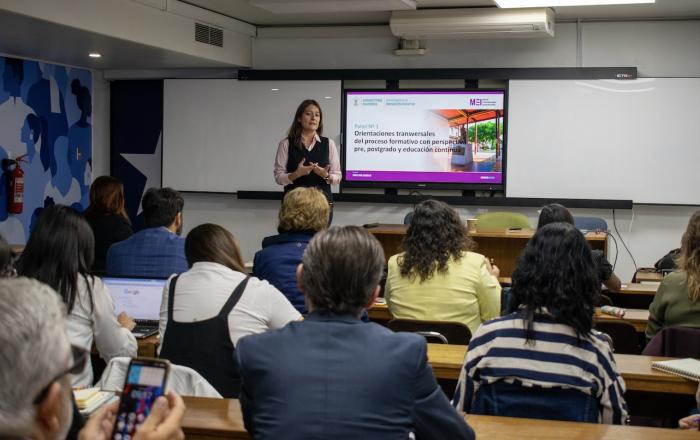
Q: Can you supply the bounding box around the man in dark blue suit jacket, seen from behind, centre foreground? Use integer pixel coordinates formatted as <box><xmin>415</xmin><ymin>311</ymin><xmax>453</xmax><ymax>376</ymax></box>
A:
<box><xmin>236</xmin><ymin>226</ymin><xmax>474</xmax><ymax>440</ymax></box>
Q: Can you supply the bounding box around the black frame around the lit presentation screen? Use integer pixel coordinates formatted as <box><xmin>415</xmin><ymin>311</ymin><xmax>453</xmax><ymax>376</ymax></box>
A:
<box><xmin>340</xmin><ymin>87</ymin><xmax>508</xmax><ymax>192</ymax></box>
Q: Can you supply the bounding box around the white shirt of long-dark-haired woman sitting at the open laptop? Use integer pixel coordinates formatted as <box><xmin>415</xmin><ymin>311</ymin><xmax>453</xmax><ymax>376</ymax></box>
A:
<box><xmin>68</xmin><ymin>276</ymin><xmax>138</xmax><ymax>387</ymax></box>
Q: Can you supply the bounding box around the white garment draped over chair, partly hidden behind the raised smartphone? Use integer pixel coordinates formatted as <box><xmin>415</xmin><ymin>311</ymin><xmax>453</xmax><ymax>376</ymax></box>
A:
<box><xmin>97</xmin><ymin>357</ymin><xmax>221</xmax><ymax>398</ymax></box>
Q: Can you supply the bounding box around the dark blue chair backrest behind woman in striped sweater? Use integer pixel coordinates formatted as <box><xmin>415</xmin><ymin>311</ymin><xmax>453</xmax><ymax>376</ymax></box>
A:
<box><xmin>469</xmin><ymin>381</ymin><xmax>600</xmax><ymax>423</ymax></box>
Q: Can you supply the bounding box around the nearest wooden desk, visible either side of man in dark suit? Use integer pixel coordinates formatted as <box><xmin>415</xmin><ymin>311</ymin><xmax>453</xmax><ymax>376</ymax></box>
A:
<box><xmin>182</xmin><ymin>397</ymin><xmax>698</xmax><ymax>440</ymax></box>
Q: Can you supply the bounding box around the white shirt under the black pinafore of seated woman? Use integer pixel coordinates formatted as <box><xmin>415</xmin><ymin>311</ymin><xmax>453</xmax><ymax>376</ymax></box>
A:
<box><xmin>160</xmin><ymin>262</ymin><xmax>301</xmax><ymax>347</ymax></box>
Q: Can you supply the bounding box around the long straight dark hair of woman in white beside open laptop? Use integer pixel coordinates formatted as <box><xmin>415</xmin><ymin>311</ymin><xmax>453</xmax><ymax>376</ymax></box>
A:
<box><xmin>17</xmin><ymin>205</ymin><xmax>95</xmax><ymax>313</ymax></box>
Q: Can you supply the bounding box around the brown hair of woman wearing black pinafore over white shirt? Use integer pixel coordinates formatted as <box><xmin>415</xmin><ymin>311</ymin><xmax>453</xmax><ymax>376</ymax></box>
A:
<box><xmin>185</xmin><ymin>223</ymin><xmax>246</xmax><ymax>274</ymax></box>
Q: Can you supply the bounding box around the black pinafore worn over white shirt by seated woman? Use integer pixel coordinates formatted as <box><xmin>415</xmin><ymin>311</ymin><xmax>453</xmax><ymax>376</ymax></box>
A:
<box><xmin>160</xmin><ymin>275</ymin><xmax>248</xmax><ymax>398</ymax></box>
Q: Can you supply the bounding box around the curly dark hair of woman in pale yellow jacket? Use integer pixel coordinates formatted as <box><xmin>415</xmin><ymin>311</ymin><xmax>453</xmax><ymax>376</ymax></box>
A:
<box><xmin>398</xmin><ymin>200</ymin><xmax>474</xmax><ymax>282</ymax></box>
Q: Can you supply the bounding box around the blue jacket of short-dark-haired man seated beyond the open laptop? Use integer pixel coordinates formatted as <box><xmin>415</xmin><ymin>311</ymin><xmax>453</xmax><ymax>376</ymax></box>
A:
<box><xmin>107</xmin><ymin>227</ymin><xmax>187</xmax><ymax>278</ymax></box>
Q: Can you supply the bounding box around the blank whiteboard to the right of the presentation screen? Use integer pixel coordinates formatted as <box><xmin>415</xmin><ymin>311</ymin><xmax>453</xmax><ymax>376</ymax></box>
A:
<box><xmin>506</xmin><ymin>78</ymin><xmax>700</xmax><ymax>205</ymax></box>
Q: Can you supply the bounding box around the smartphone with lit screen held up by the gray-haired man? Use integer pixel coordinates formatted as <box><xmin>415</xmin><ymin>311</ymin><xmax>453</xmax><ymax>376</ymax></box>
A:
<box><xmin>112</xmin><ymin>359</ymin><xmax>170</xmax><ymax>440</ymax></box>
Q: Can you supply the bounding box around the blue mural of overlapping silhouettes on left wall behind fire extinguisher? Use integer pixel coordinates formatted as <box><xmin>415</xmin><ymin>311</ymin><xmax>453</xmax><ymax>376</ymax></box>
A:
<box><xmin>0</xmin><ymin>57</ymin><xmax>92</xmax><ymax>244</ymax></box>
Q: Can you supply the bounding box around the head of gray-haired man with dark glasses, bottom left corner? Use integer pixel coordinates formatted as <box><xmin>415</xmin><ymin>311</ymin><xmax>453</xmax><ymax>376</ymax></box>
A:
<box><xmin>0</xmin><ymin>278</ymin><xmax>77</xmax><ymax>439</ymax></box>
